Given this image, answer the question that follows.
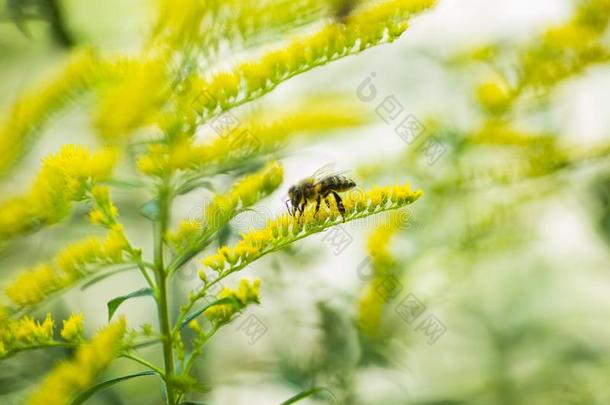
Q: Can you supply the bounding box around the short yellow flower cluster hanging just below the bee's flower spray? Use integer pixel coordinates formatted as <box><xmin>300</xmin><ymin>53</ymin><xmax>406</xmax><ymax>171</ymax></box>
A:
<box><xmin>204</xmin><ymin>278</ymin><xmax>261</xmax><ymax>323</ymax></box>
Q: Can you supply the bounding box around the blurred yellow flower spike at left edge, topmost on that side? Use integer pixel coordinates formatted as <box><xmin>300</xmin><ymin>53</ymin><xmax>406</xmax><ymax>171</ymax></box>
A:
<box><xmin>0</xmin><ymin>51</ymin><xmax>97</xmax><ymax>176</ymax></box>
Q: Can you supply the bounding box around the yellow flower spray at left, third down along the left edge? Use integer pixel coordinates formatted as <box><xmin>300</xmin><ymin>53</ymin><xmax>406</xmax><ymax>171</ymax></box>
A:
<box><xmin>6</xmin><ymin>224</ymin><xmax>130</xmax><ymax>306</ymax></box>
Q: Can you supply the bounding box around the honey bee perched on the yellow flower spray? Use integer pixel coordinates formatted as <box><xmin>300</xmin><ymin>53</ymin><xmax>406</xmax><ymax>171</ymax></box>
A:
<box><xmin>286</xmin><ymin>164</ymin><xmax>356</xmax><ymax>222</ymax></box>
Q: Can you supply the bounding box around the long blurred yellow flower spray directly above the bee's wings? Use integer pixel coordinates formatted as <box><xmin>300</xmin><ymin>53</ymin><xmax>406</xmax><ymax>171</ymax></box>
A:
<box><xmin>138</xmin><ymin>97</ymin><xmax>369</xmax><ymax>176</ymax></box>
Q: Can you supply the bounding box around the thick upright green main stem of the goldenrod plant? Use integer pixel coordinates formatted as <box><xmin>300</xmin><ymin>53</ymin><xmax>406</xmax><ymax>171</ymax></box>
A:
<box><xmin>154</xmin><ymin>181</ymin><xmax>176</xmax><ymax>405</ymax></box>
